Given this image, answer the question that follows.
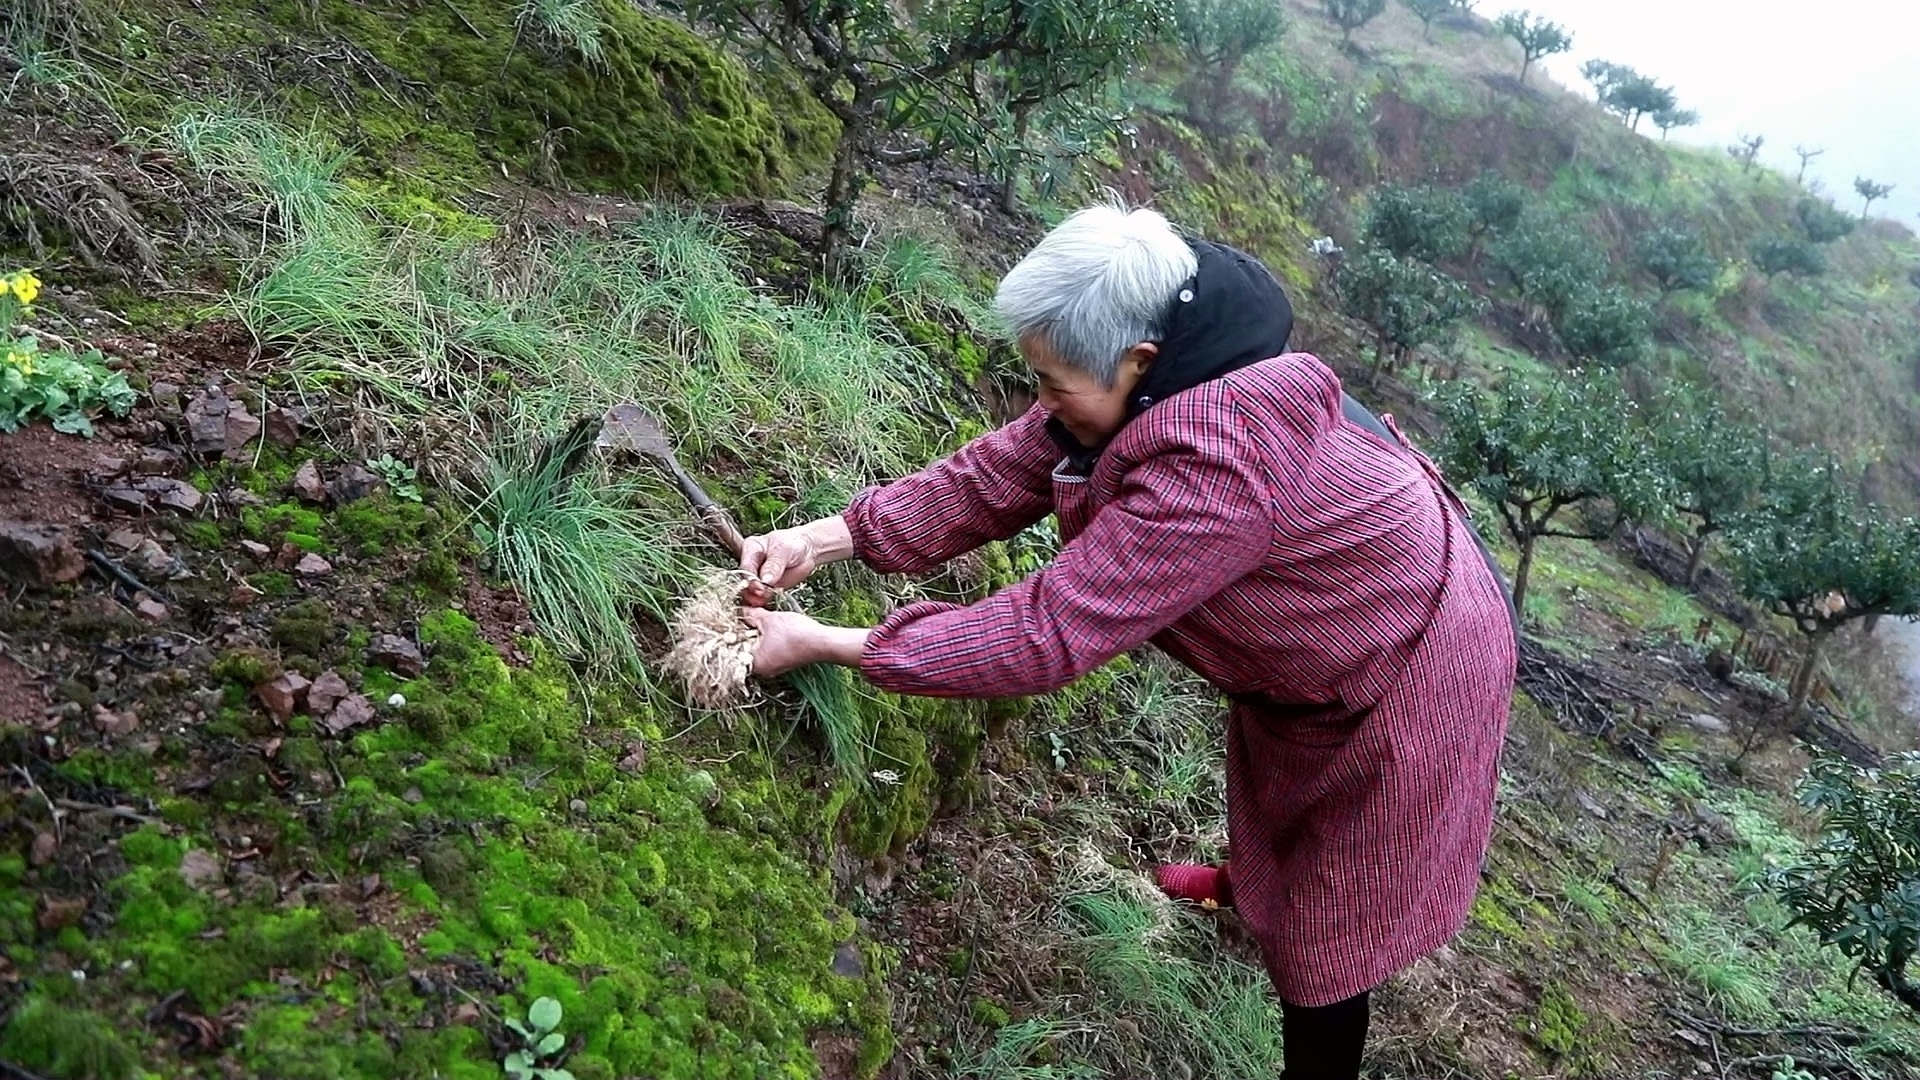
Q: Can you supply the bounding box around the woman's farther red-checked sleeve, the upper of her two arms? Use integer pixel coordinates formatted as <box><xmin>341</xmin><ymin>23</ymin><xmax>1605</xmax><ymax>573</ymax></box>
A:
<box><xmin>841</xmin><ymin>405</ymin><xmax>1060</xmax><ymax>573</ymax></box>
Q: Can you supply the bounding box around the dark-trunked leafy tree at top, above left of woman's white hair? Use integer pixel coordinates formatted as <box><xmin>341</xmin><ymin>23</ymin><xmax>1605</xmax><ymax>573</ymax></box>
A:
<box><xmin>685</xmin><ymin>0</ymin><xmax>1171</xmax><ymax>275</ymax></box>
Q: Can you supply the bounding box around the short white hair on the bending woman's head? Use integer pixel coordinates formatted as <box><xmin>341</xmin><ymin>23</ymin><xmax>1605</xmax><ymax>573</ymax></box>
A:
<box><xmin>993</xmin><ymin>204</ymin><xmax>1198</xmax><ymax>386</ymax></box>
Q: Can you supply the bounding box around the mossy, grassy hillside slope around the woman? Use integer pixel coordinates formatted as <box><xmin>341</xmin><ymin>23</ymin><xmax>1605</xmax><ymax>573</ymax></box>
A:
<box><xmin>0</xmin><ymin>0</ymin><xmax>1920</xmax><ymax>1080</ymax></box>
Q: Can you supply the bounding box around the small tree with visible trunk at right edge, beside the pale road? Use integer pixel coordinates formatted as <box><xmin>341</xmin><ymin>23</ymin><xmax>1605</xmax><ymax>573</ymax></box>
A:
<box><xmin>1726</xmin><ymin>454</ymin><xmax>1920</xmax><ymax>717</ymax></box>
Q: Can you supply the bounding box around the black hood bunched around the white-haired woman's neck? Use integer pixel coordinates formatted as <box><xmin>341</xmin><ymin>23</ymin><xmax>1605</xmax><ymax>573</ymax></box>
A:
<box><xmin>1046</xmin><ymin>240</ymin><xmax>1294</xmax><ymax>471</ymax></box>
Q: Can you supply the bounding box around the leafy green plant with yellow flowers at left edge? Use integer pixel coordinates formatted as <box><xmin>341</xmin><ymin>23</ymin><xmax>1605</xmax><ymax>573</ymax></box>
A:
<box><xmin>0</xmin><ymin>271</ymin><xmax>138</xmax><ymax>436</ymax></box>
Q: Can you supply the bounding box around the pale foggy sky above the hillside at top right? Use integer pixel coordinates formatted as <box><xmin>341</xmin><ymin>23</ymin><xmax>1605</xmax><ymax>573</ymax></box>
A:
<box><xmin>1497</xmin><ymin>0</ymin><xmax>1920</xmax><ymax>224</ymax></box>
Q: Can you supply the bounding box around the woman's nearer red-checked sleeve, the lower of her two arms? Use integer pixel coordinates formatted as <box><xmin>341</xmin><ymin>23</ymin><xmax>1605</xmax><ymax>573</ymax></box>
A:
<box><xmin>860</xmin><ymin>402</ymin><xmax>1273</xmax><ymax>698</ymax></box>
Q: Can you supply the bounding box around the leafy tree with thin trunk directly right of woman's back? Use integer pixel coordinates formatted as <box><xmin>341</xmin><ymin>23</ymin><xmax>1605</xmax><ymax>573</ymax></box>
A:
<box><xmin>1436</xmin><ymin>371</ymin><xmax>1663</xmax><ymax>611</ymax></box>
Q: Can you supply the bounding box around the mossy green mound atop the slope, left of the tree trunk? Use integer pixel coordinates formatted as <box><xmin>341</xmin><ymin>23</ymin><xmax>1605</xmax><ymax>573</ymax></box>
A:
<box><xmin>151</xmin><ymin>0</ymin><xmax>837</xmax><ymax>197</ymax></box>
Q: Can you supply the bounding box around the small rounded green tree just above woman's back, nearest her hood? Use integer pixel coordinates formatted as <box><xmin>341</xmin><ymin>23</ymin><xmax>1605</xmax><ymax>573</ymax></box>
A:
<box><xmin>1332</xmin><ymin>246</ymin><xmax>1480</xmax><ymax>375</ymax></box>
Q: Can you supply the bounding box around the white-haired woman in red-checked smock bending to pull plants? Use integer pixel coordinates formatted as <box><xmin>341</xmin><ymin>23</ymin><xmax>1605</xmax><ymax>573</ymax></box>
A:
<box><xmin>741</xmin><ymin>208</ymin><xmax>1515</xmax><ymax>1078</ymax></box>
